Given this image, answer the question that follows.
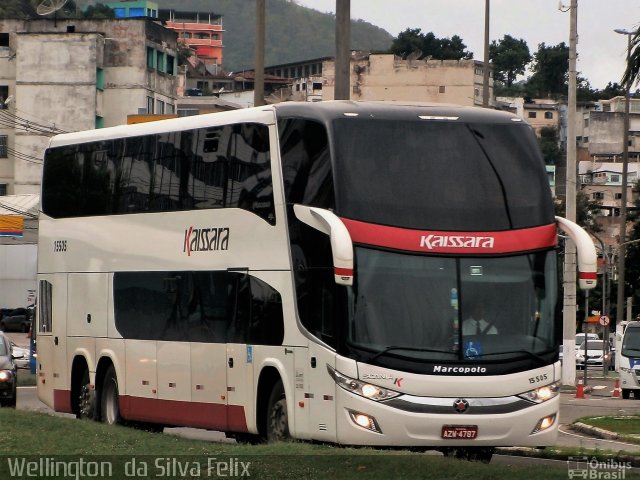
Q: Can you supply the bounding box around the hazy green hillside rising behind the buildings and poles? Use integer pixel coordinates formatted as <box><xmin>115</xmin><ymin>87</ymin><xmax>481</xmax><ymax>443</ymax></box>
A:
<box><xmin>157</xmin><ymin>0</ymin><xmax>393</xmax><ymax>70</ymax></box>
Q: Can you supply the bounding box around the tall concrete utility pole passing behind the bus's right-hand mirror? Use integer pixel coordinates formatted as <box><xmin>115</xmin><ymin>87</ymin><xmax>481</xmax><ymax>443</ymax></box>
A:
<box><xmin>562</xmin><ymin>0</ymin><xmax>578</xmax><ymax>386</ymax></box>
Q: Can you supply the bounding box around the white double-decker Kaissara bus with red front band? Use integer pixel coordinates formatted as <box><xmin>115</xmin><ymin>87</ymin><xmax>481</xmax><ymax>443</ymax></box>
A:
<box><xmin>37</xmin><ymin>101</ymin><xmax>596</xmax><ymax>459</ymax></box>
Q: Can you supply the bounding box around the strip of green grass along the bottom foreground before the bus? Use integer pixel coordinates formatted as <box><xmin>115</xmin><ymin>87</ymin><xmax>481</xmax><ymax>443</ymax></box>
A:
<box><xmin>0</xmin><ymin>409</ymin><xmax>588</xmax><ymax>480</ymax></box>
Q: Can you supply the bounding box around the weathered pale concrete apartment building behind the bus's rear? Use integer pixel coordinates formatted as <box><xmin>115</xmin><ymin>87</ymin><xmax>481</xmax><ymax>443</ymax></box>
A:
<box><xmin>0</xmin><ymin>18</ymin><xmax>177</xmax><ymax>195</ymax></box>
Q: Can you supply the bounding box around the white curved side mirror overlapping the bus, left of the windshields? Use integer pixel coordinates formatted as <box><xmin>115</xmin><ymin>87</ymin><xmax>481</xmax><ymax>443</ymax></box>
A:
<box><xmin>293</xmin><ymin>204</ymin><xmax>353</xmax><ymax>285</ymax></box>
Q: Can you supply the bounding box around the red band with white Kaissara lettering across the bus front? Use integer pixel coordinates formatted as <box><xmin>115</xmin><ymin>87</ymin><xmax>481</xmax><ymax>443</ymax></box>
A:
<box><xmin>341</xmin><ymin>218</ymin><xmax>558</xmax><ymax>254</ymax></box>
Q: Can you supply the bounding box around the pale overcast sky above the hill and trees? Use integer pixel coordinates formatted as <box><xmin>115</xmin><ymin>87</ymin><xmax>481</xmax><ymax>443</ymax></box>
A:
<box><xmin>295</xmin><ymin>0</ymin><xmax>640</xmax><ymax>89</ymax></box>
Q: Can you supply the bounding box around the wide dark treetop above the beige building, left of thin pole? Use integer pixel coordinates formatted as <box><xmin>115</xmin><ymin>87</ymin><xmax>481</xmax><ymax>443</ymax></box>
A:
<box><xmin>389</xmin><ymin>28</ymin><xmax>473</xmax><ymax>60</ymax></box>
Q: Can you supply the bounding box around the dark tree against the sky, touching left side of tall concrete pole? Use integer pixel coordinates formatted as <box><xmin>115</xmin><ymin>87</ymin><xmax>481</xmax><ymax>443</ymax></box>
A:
<box><xmin>527</xmin><ymin>42</ymin><xmax>569</xmax><ymax>97</ymax></box>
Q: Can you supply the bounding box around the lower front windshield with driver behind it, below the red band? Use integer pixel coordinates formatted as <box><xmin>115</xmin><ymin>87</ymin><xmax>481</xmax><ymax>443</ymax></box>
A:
<box><xmin>347</xmin><ymin>247</ymin><xmax>558</xmax><ymax>370</ymax></box>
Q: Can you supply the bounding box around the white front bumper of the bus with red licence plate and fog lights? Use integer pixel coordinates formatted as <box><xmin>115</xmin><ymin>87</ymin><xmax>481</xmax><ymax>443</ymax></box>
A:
<box><xmin>336</xmin><ymin>389</ymin><xmax>560</xmax><ymax>448</ymax></box>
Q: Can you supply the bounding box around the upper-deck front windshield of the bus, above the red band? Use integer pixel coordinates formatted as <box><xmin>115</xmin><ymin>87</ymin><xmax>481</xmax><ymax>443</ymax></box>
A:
<box><xmin>333</xmin><ymin>118</ymin><xmax>554</xmax><ymax>231</ymax></box>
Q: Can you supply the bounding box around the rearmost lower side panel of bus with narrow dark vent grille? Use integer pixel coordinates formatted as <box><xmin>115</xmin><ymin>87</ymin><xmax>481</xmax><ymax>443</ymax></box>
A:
<box><xmin>36</xmin><ymin>274</ymin><xmax>71</xmax><ymax>413</ymax></box>
